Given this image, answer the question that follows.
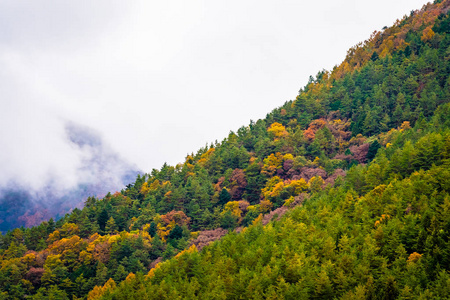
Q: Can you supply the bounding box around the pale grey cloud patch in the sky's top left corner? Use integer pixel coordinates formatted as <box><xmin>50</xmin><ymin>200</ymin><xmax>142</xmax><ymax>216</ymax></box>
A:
<box><xmin>0</xmin><ymin>0</ymin><xmax>128</xmax><ymax>48</ymax></box>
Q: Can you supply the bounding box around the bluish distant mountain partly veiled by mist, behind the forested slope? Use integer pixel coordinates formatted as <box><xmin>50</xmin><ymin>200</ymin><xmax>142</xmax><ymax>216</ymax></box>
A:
<box><xmin>0</xmin><ymin>123</ymin><xmax>139</xmax><ymax>232</ymax></box>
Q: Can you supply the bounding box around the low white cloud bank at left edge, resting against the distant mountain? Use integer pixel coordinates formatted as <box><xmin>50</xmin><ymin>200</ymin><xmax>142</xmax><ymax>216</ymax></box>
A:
<box><xmin>0</xmin><ymin>68</ymin><xmax>80</xmax><ymax>189</ymax></box>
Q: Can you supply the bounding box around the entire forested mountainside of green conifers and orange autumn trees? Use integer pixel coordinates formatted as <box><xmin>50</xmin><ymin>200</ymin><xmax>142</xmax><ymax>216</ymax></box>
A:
<box><xmin>0</xmin><ymin>0</ymin><xmax>450</xmax><ymax>299</ymax></box>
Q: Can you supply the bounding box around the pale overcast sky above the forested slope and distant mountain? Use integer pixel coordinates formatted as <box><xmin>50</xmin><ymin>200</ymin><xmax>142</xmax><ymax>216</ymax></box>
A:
<box><xmin>0</xmin><ymin>0</ymin><xmax>426</xmax><ymax>189</ymax></box>
